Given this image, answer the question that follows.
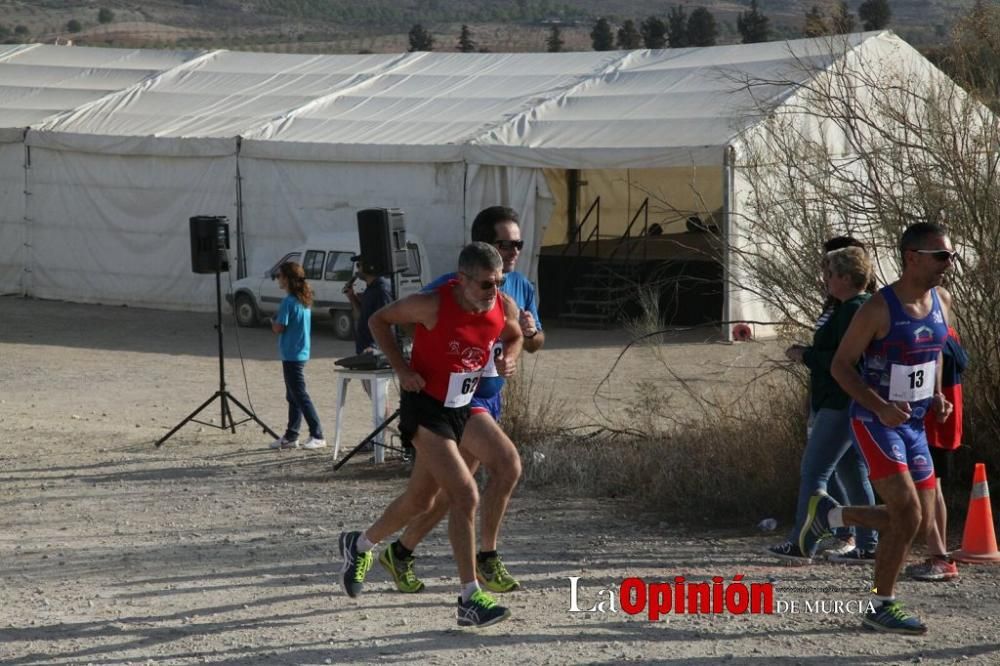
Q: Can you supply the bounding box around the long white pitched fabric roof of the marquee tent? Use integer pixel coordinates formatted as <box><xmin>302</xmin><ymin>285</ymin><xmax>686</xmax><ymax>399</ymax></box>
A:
<box><xmin>0</xmin><ymin>32</ymin><xmax>916</xmax><ymax>168</ymax></box>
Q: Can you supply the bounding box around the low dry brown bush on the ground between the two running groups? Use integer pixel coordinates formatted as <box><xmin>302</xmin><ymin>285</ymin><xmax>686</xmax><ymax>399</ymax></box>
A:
<box><xmin>519</xmin><ymin>374</ymin><xmax>806</xmax><ymax>527</ymax></box>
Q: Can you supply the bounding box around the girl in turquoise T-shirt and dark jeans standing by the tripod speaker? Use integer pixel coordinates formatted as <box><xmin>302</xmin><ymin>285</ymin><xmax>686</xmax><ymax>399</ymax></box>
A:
<box><xmin>271</xmin><ymin>261</ymin><xmax>326</xmax><ymax>449</ymax></box>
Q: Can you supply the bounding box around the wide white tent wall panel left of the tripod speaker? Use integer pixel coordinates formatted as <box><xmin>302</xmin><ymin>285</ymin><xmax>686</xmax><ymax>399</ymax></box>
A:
<box><xmin>26</xmin><ymin>148</ymin><xmax>236</xmax><ymax>309</ymax></box>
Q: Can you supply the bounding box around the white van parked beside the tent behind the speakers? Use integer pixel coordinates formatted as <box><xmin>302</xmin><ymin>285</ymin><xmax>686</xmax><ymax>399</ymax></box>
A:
<box><xmin>226</xmin><ymin>233</ymin><xmax>430</xmax><ymax>340</ymax></box>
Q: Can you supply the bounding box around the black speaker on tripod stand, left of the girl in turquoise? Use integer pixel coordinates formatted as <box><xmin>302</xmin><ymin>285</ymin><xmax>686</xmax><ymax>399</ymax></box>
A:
<box><xmin>156</xmin><ymin>215</ymin><xmax>278</xmax><ymax>448</ymax></box>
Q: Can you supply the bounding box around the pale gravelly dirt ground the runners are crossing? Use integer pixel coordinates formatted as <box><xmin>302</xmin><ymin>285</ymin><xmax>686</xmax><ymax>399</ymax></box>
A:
<box><xmin>0</xmin><ymin>297</ymin><xmax>1000</xmax><ymax>665</ymax></box>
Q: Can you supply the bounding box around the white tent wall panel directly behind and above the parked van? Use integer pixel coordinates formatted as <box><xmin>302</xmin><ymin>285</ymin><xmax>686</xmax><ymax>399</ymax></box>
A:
<box><xmin>239</xmin><ymin>154</ymin><xmax>465</xmax><ymax>275</ymax></box>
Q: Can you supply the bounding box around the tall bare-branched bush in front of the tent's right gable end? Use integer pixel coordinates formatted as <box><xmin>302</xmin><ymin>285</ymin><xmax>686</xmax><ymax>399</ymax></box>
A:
<box><xmin>730</xmin><ymin>22</ymin><xmax>1000</xmax><ymax>498</ymax></box>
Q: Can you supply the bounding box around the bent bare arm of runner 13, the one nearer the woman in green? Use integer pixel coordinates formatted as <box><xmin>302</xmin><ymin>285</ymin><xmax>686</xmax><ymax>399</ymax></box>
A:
<box><xmin>830</xmin><ymin>296</ymin><xmax>910</xmax><ymax>428</ymax></box>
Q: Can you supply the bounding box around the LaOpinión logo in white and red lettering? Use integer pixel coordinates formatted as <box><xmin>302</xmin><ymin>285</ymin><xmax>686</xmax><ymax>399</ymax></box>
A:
<box><xmin>568</xmin><ymin>574</ymin><xmax>774</xmax><ymax>622</ymax></box>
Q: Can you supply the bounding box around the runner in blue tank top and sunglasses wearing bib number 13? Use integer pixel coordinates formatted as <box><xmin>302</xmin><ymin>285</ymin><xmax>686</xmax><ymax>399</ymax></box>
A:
<box><xmin>799</xmin><ymin>222</ymin><xmax>957</xmax><ymax>634</ymax></box>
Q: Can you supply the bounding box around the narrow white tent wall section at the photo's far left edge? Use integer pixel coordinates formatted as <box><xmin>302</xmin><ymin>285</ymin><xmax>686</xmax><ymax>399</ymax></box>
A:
<box><xmin>0</xmin><ymin>143</ymin><xmax>27</xmax><ymax>295</ymax></box>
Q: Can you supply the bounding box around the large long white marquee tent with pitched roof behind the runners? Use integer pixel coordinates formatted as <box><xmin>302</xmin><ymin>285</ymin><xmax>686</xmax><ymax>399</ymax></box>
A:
<box><xmin>0</xmin><ymin>32</ymin><xmax>948</xmax><ymax>332</ymax></box>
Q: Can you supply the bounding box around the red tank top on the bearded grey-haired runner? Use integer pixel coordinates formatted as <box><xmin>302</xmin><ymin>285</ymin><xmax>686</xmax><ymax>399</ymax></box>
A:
<box><xmin>410</xmin><ymin>280</ymin><xmax>506</xmax><ymax>407</ymax></box>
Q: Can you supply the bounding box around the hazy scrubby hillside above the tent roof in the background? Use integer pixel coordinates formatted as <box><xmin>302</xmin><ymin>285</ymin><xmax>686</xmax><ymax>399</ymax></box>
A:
<box><xmin>0</xmin><ymin>0</ymin><xmax>972</xmax><ymax>53</ymax></box>
